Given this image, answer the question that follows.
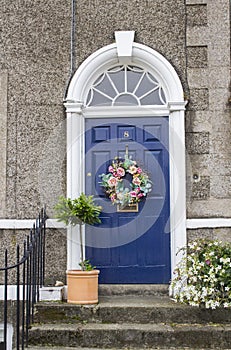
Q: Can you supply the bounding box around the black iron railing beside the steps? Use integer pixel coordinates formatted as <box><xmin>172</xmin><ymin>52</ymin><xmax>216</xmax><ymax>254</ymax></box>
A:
<box><xmin>0</xmin><ymin>209</ymin><xmax>47</xmax><ymax>350</ymax></box>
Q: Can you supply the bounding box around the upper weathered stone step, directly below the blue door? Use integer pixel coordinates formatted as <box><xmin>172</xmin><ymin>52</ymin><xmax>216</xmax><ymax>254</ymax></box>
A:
<box><xmin>35</xmin><ymin>295</ymin><xmax>231</xmax><ymax>324</ymax></box>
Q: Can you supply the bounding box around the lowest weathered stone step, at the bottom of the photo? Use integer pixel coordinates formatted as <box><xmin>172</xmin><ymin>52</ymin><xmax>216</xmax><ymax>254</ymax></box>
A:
<box><xmin>29</xmin><ymin>323</ymin><xmax>231</xmax><ymax>349</ymax></box>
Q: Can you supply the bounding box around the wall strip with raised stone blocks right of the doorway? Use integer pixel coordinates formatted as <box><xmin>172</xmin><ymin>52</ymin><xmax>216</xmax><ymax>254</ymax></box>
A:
<box><xmin>186</xmin><ymin>0</ymin><xmax>231</xmax><ymax>218</ymax></box>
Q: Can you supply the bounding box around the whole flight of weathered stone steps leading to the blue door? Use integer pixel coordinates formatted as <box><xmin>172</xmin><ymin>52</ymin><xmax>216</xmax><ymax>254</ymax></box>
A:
<box><xmin>29</xmin><ymin>294</ymin><xmax>231</xmax><ymax>350</ymax></box>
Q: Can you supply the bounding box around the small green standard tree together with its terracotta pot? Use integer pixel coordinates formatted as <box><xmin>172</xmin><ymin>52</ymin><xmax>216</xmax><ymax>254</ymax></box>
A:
<box><xmin>54</xmin><ymin>193</ymin><xmax>102</xmax><ymax>304</ymax></box>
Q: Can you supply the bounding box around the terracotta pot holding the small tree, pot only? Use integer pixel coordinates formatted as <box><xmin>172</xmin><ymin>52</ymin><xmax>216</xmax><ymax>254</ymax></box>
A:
<box><xmin>67</xmin><ymin>270</ymin><xmax>99</xmax><ymax>304</ymax></box>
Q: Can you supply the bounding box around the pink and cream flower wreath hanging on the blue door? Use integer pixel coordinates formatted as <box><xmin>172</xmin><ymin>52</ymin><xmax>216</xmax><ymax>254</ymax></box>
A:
<box><xmin>99</xmin><ymin>155</ymin><xmax>152</xmax><ymax>207</ymax></box>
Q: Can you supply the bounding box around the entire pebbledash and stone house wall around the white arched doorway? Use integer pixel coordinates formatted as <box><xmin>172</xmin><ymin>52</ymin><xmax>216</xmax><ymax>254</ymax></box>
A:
<box><xmin>0</xmin><ymin>0</ymin><xmax>231</xmax><ymax>283</ymax></box>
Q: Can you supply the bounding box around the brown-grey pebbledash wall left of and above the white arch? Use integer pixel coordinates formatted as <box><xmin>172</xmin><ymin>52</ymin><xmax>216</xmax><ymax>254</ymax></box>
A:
<box><xmin>0</xmin><ymin>0</ymin><xmax>187</xmax><ymax>219</ymax></box>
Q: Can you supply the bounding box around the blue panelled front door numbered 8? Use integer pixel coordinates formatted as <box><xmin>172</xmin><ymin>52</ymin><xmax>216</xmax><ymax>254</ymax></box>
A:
<box><xmin>85</xmin><ymin>117</ymin><xmax>170</xmax><ymax>284</ymax></box>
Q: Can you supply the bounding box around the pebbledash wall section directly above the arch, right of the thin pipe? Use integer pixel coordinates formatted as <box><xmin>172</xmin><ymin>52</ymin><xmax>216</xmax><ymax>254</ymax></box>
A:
<box><xmin>76</xmin><ymin>0</ymin><xmax>187</xmax><ymax>89</ymax></box>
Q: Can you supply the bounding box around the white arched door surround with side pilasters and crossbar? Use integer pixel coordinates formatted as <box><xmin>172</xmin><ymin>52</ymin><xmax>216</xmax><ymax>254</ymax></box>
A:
<box><xmin>65</xmin><ymin>36</ymin><xmax>186</xmax><ymax>282</ymax></box>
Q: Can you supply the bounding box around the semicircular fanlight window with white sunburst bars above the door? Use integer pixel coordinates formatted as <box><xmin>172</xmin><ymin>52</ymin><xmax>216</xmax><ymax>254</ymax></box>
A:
<box><xmin>86</xmin><ymin>65</ymin><xmax>166</xmax><ymax>107</ymax></box>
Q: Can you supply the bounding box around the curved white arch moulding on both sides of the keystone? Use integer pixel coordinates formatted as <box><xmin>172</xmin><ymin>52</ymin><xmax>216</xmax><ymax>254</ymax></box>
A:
<box><xmin>66</xmin><ymin>43</ymin><xmax>185</xmax><ymax>105</ymax></box>
